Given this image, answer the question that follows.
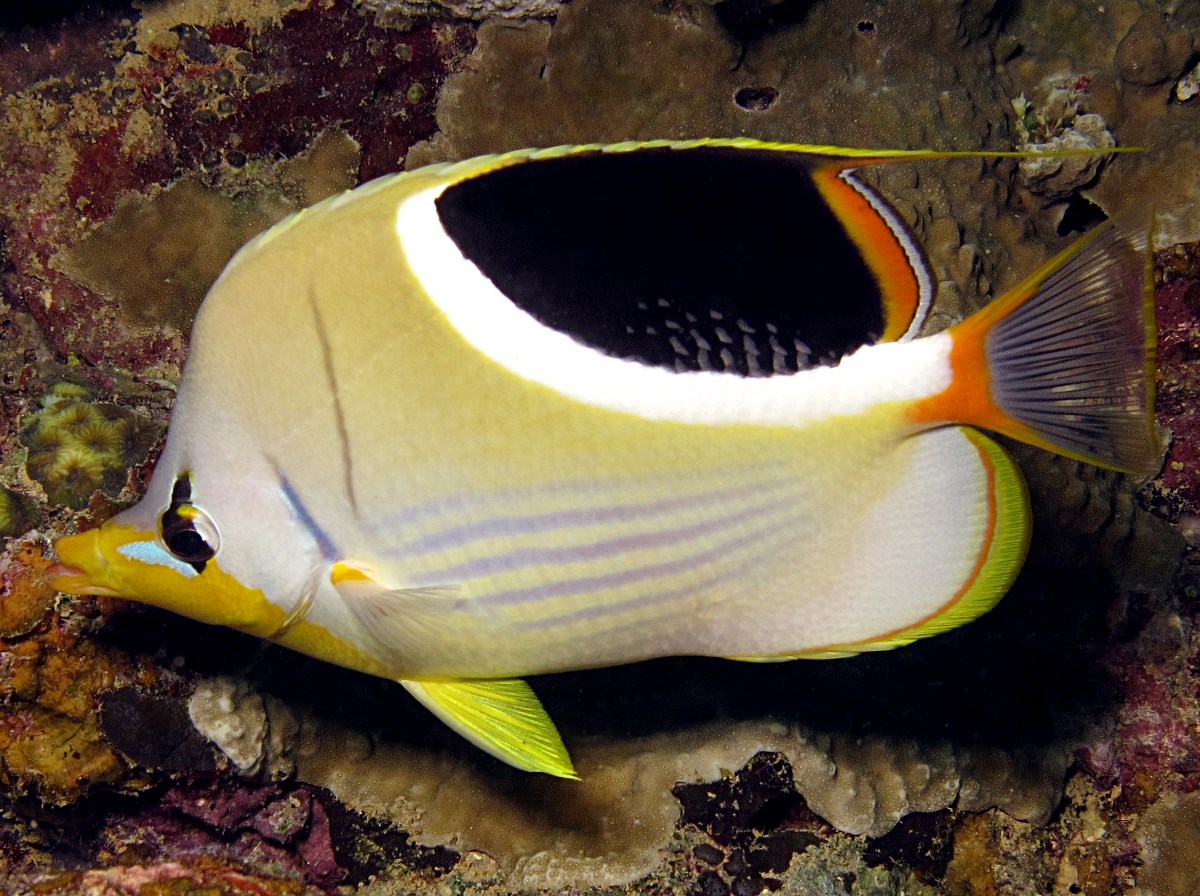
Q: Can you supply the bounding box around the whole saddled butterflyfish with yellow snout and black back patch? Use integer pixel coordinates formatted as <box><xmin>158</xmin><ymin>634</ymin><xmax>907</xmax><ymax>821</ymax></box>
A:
<box><xmin>54</xmin><ymin>139</ymin><xmax>1160</xmax><ymax>777</ymax></box>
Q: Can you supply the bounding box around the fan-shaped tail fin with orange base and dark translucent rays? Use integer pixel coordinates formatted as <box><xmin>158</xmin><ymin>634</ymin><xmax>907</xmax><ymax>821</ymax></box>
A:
<box><xmin>919</xmin><ymin>222</ymin><xmax>1162</xmax><ymax>476</ymax></box>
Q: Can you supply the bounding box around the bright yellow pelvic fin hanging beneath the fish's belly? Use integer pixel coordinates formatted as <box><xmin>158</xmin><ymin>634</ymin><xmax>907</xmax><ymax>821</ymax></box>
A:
<box><xmin>400</xmin><ymin>678</ymin><xmax>580</xmax><ymax>781</ymax></box>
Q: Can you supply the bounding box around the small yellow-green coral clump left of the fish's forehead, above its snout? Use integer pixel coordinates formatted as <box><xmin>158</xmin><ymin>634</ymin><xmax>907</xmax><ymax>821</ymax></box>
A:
<box><xmin>20</xmin><ymin>383</ymin><xmax>160</xmax><ymax>510</ymax></box>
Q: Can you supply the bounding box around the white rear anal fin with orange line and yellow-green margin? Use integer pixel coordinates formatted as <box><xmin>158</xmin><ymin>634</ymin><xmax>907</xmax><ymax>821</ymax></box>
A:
<box><xmin>724</xmin><ymin>426</ymin><xmax>1030</xmax><ymax>662</ymax></box>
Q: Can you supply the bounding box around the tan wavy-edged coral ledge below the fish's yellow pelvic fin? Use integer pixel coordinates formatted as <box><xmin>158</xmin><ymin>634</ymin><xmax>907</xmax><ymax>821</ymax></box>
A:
<box><xmin>300</xmin><ymin>720</ymin><xmax>1070</xmax><ymax>889</ymax></box>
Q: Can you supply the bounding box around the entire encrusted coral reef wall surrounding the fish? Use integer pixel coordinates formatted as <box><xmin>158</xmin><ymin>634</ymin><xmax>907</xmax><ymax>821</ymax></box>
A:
<box><xmin>0</xmin><ymin>0</ymin><xmax>1200</xmax><ymax>896</ymax></box>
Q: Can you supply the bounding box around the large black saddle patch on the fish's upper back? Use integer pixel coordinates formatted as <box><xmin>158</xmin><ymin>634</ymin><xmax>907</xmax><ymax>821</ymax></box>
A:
<box><xmin>437</xmin><ymin>146</ymin><xmax>884</xmax><ymax>375</ymax></box>
